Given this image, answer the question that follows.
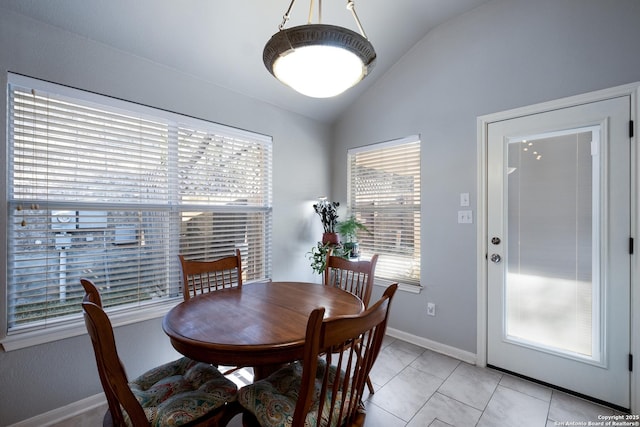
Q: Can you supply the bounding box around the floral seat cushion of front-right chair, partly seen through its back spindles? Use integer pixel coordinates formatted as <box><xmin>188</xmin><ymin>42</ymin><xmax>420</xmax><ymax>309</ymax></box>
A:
<box><xmin>238</xmin><ymin>359</ymin><xmax>349</xmax><ymax>427</ymax></box>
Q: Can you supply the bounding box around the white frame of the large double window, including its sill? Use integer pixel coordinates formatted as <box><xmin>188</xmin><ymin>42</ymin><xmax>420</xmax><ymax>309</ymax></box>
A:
<box><xmin>0</xmin><ymin>73</ymin><xmax>273</xmax><ymax>351</ymax></box>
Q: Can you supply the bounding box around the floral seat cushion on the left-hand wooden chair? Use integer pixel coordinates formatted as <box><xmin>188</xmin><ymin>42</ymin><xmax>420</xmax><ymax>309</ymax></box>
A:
<box><xmin>125</xmin><ymin>357</ymin><xmax>238</xmax><ymax>426</ymax></box>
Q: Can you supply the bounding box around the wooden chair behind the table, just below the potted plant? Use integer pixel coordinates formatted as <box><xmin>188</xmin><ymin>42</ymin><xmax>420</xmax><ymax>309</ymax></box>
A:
<box><xmin>324</xmin><ymin>251</ymin><xmax>378</xmax><ymax>394</ymax></box>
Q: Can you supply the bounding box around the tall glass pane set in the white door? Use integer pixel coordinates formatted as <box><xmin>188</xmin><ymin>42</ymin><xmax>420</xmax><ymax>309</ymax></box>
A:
<box><xmin>505</xmin><ymin>128</ymin><xmax>600</xmax><ymax>359</ymax></box>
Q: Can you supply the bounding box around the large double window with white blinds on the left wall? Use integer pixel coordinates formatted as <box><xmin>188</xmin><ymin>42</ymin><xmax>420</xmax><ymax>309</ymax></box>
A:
<box><xmin>3</xmin><ymin>75</ymin><xmax>272</xmax><ymax>348</ymax></box>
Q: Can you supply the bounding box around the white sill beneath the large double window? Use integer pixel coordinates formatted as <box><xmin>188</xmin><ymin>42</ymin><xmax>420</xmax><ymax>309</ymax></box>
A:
<box><xmin>0</xmin><ymin>298</ymin><xmax>182</xmax><ymax>351</ymax></box>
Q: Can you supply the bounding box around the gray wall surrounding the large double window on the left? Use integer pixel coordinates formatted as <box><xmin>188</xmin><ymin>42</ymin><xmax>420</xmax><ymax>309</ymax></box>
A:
<box><xmin>0</xmin><ymin>6</ymin><xmax>330</xmax><ymax>426</ymax></box>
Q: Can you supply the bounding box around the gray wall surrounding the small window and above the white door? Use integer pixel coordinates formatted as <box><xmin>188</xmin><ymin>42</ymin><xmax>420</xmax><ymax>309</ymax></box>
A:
<box><xmin>332</xmin><ymin>0</ymin><xmax>640</xmax><ymax>353</ymax></box>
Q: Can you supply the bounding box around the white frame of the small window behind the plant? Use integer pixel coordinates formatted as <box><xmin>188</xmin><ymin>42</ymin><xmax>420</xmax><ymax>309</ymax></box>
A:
<box><xmin>347</xmin><ymin>135</ymin><xmax>423</xmax><ymax>293</ymax></box>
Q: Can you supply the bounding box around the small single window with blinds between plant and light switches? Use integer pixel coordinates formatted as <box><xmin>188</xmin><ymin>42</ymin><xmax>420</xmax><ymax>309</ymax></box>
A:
<box><xmin>348</xmin><ymin>136</ymin><xmax>420</xmax><ymax>286</ymax></box>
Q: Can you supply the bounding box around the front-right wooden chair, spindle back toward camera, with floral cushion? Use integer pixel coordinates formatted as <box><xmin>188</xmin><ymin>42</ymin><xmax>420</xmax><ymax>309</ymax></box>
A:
<box><xmin>238</xmin><ymin>283</ymin><xmax>398</xmax><ymax>427</ymax></box>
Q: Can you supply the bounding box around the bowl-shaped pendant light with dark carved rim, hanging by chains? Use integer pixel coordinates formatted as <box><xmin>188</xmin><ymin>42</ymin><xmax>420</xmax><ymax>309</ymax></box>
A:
<box><xmin>263</xmin><ymin>0</ymin><xmax>376</xmax><ymax>98</ymax></box>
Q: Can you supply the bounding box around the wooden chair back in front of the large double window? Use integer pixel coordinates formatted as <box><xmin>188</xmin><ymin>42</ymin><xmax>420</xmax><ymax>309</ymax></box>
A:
<box><xmin>178</xmin><ymin>249</ymin><xmax>242</xmax><ymax>301</ymax></box>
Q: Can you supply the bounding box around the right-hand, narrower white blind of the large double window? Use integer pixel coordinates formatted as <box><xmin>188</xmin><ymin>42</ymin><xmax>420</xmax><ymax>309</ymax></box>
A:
<box><xmin>178</xmin><ymin>126</ymin><xmax>272</xmax><ymax>281</ymax></box>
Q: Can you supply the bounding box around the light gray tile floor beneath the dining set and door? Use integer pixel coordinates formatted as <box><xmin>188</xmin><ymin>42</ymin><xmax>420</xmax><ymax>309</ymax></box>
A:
<box><xmin>55</xmin><ymin>338</ymin><xmax>619</xmax><ymax>427</ymax></box>
